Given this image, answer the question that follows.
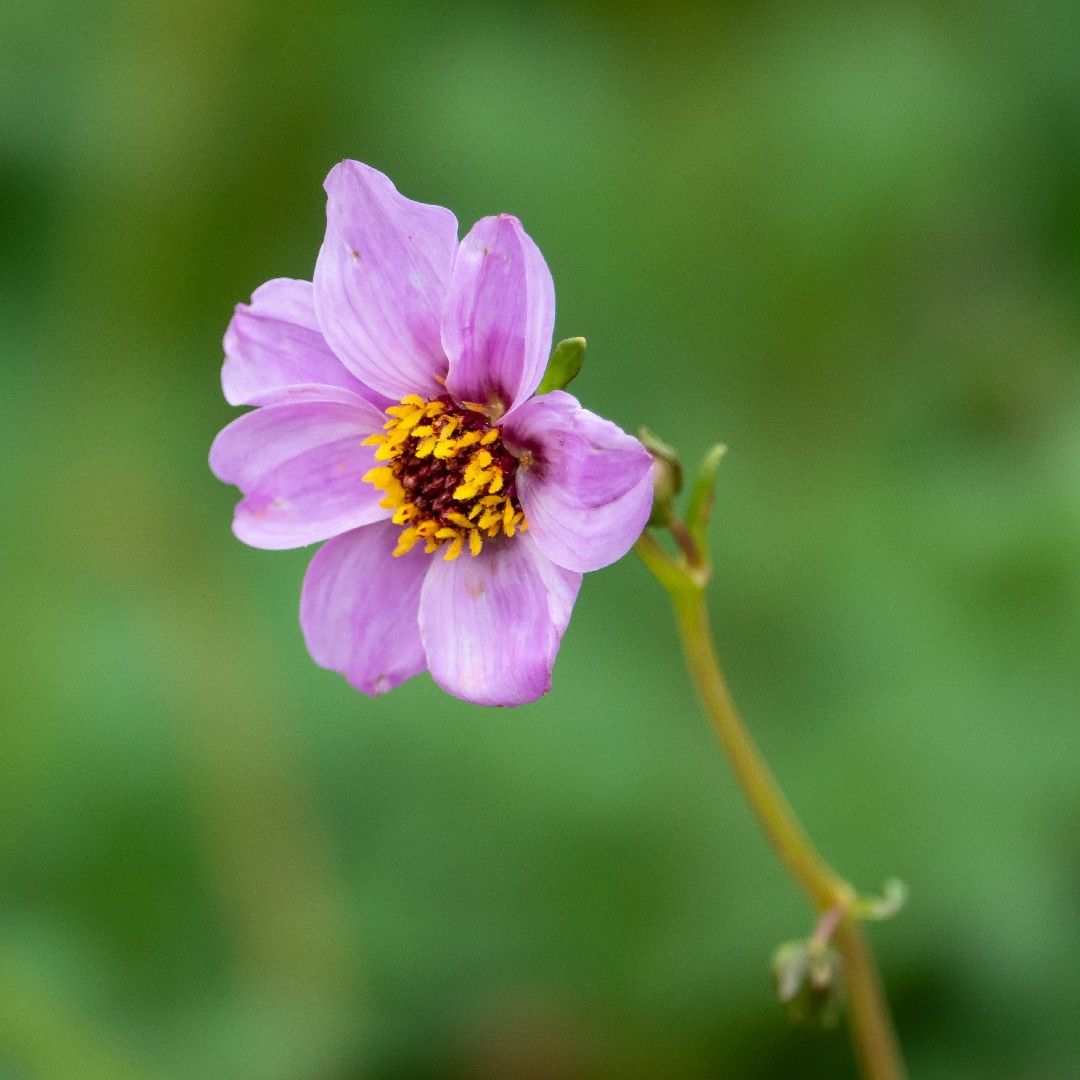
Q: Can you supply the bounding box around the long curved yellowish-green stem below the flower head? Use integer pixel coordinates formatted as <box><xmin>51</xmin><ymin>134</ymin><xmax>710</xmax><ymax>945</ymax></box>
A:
<box><xmin>636</xmin><ymin>534</ymin><xmax>906</xmax><ymax>1080</ymax></box>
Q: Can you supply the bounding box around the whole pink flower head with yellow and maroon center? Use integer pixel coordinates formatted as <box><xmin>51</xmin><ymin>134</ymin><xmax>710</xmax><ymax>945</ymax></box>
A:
<box><xmin>210</xmin><ymin>161</ymin><xmax>652</xmax><ymax>705</ymax></box>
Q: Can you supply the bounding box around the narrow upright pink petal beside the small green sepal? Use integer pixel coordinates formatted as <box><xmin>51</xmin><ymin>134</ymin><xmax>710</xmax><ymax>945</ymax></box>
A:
<box><xmin>443</xmin><ymin>214</ymin><xmax>555</xmax><ymax>411</ymax></box>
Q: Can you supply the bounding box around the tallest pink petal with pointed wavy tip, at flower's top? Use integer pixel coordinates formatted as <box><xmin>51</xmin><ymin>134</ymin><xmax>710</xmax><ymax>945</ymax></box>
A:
<box><xmin>314</xmin><ymin>161</ymin><xmax>458</xmax><ymax>401</ymax></box>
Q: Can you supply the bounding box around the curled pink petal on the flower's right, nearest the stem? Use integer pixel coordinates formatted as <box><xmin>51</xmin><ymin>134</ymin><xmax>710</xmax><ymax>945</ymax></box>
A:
<box><xmin>503</xmin><ymin>390</ymin><xmax>652</xmax><ymax>570</ymax></box>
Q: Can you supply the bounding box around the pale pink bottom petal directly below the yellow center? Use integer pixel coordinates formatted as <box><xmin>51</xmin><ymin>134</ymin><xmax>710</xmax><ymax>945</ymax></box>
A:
<box><xmin>420</xmin><ymin>532</ymin><xmax>581</xmax><ymax>705</ymax></box>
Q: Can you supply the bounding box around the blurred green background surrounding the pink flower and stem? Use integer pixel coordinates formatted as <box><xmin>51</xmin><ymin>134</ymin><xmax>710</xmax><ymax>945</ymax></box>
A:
<box><xmin>0</xmin><ymin>0</ymin><xmax>1080</xmax><ymax>1080</ymax></box>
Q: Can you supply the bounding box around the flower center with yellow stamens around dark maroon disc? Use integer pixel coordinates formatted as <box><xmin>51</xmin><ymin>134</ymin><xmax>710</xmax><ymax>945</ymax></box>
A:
<box><xmin>364</xmin><ymin>394</ymin><xmax>528</xmax><ymax>559</ymax></box>
